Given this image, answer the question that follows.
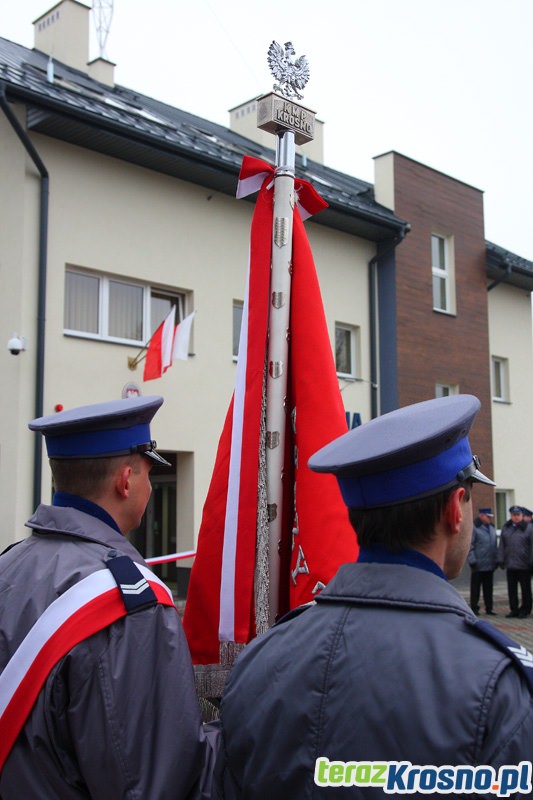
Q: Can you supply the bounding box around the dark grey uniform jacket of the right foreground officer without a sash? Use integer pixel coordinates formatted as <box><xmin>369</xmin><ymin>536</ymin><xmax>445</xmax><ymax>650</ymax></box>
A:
<box><xmin>216</xmin><ymin>563</ymin><xmax>533</xmax><ymax>800</ymax></box>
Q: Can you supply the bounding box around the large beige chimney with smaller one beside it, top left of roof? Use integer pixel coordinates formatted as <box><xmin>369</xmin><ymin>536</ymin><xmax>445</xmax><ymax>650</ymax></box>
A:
<box><xmin>33</xmin><ymin>0</ymin><xmax>115</xmax><ymax>86</ymax></box>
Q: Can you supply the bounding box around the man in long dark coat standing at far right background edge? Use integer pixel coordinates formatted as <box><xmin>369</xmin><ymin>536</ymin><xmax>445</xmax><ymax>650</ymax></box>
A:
<box><xmin>498</xmin><ymin>506</ymin><xmax>533</xmax><ymax>619</ymax></box>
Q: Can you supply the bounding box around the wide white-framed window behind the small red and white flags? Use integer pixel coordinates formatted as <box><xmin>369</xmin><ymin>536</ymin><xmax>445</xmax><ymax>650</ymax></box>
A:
<box><xmin>64</xmin><ymin>268</ymin><xmax>185</xmax><ymax>344</ymax></box>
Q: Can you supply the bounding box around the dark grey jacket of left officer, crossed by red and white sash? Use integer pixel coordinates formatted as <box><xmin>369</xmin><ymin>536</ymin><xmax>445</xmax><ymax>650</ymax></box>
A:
<box><xmin>0</xmin><ymin>505</ymin><xmax>216</xmax><ymax>800</ymax></box>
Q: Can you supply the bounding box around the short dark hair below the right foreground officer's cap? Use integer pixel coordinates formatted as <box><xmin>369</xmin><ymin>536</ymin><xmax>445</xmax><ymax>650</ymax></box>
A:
<box><xmin>348</xmin><ymin>482</ymin><xmax>471</xmax><ymax>552</ymax></box>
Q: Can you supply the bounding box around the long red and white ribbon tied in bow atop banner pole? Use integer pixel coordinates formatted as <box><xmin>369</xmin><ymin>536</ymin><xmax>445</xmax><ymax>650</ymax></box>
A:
<box><xmin>218</xmin><ymin>156</ymin><xmax>340</xmax><ymax>642</ymax></box>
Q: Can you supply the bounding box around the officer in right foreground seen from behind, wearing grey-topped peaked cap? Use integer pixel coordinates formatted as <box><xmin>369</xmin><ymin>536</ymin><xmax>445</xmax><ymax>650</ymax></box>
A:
<box><xmin>216</xmin><ymin>395</ymin><xmax>533</xmax><ymax>800</ymax></box>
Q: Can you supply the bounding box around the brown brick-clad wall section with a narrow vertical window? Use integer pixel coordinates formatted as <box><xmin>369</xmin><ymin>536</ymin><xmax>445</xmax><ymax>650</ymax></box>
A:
<box><xmin>386</xmin><ymin>154</ymin><xmax>494</xmax><ymax>509</ymax></box>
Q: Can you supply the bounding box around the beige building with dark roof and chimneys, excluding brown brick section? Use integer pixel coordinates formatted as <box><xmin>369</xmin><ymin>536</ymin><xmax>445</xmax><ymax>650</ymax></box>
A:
<box><xmin>0</xmin><ymin>0</ymin><xmax>533</xmax><ymax>578</ymax></box>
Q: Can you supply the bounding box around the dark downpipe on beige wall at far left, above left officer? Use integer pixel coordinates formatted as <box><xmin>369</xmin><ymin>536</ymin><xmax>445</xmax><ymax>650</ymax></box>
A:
<box><xmin>0</xmin><ymin>83</ymin><xmax>50</xmax><ymax>509</ymax></box>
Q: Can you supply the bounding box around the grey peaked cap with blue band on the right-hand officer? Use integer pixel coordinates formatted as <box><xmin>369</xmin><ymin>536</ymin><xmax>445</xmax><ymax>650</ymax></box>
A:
<box><xmin>308</xmin><ymin>395</ymin><xmax>495</xmax><ymax>508</ymax></box>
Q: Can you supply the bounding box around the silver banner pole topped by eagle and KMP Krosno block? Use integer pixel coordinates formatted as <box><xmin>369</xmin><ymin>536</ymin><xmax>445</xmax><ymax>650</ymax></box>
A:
<box><xmin>257</xmin><ymin>42</ymin><xmax>315</xmax><ymax>625</ymax></box>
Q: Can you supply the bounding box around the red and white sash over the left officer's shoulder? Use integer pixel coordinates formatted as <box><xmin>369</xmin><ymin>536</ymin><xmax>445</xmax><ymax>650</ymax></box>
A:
<box><xmin>0</xmin><ymin>564</ymin><xmax>175</xmax><ymax>771</ymax></box>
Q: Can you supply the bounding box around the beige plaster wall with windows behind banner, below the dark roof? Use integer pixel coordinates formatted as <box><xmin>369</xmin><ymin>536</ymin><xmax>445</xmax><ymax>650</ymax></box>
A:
<box><xmin>0</xmin><ymin>0</ymin><xmax>384</xmax><ymax>568</ymax></box>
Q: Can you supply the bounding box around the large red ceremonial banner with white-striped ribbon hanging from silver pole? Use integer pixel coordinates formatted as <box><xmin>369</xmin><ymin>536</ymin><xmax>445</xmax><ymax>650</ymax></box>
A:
<box><xmin>184</xmin><ymin>157</ymin><xmax>357</xmax><ymax>665</ymax></box>
